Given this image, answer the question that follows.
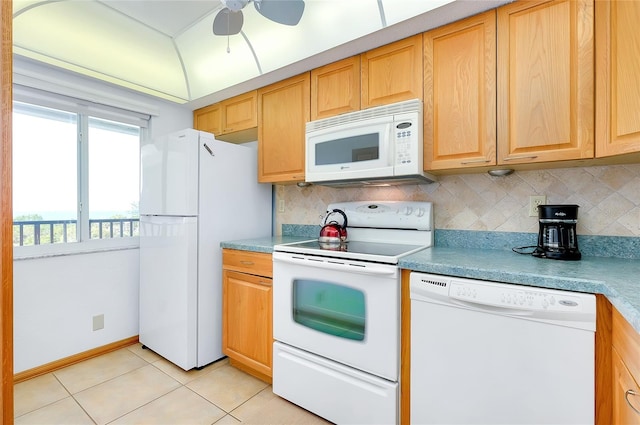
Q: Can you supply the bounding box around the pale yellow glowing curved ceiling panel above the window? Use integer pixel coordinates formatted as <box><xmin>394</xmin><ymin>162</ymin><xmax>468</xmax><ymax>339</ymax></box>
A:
<box><xmin>13</xmin><ymin>1</ymin><xmax>188</xmax><ymax>99</ymax></box>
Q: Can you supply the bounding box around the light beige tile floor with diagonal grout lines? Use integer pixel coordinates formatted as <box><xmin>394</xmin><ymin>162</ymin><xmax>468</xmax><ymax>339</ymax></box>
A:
<box><xmin>14</xmin><ymin>344</ymin><xmax>329</xmax><ymax>425</ymax></box>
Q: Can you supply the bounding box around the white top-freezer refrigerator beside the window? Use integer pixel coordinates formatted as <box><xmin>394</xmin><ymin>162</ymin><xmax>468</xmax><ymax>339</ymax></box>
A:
<box><xmin>139</xmin><ymin>129</ymin><xmax>272</xmax><ymax>370</ymax></box>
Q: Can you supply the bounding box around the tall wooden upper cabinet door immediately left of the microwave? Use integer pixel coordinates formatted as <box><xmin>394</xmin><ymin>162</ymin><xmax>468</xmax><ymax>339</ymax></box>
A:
<box><xmin>258</xmin><ymin>73</ymin><xmax>311</xmax><ymax>183</ymax></box>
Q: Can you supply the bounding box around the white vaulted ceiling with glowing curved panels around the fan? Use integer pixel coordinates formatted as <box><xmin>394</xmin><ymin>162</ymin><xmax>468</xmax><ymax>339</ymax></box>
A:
<box><xmin>13</xmin><ymin>0</ymin><xmax>504</xmax><ymax>106</ymax></box>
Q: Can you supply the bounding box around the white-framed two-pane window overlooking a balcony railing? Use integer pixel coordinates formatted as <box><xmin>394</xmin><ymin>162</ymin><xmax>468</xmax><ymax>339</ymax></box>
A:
<box><xmin>13</xmin><ymin>88</ymin><xmax>146</xmax><ymax>253</ymax></box>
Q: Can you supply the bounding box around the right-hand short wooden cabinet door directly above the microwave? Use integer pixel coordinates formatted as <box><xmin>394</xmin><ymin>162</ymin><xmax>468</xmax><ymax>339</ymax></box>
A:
<box><xmin>361</xmin><ymin>34</ymin><xmax>423</xmax><ymax>109</ymax></box>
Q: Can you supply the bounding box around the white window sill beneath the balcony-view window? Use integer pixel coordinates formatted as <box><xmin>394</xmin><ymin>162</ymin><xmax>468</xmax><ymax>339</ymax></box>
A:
<box><xmin>13</xmin><ymin>236</ymin><xmax>140</xmax><ymax>261</ymax></box>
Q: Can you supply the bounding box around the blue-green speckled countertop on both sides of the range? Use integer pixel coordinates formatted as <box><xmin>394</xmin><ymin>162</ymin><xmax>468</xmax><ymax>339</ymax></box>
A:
<box><xmin>220</xmin><ymin>236</ymin><xmax>640</xmax><ymax>333</ymax></box>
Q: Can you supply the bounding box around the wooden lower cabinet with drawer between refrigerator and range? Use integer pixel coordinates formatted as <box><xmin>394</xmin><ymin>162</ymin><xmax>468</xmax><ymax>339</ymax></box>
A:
<box><xmin>222</xmin><ymin>249</ymin><xmax>273</xmax><ymax>383</ymax></box>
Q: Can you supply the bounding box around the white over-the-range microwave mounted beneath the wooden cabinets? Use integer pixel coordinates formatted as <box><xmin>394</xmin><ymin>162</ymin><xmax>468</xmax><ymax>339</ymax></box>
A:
<box><xmin>305</xmin><ymin>99</ymin><xmax>434</xmax><ymax>186</ymax></box>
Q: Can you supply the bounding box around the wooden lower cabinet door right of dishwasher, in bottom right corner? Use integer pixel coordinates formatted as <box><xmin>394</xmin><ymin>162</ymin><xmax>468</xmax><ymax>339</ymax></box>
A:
<box><xmin>612</xmin><ymin>349</ymin><xmax>640</xmax><ymax>425</ymax></box>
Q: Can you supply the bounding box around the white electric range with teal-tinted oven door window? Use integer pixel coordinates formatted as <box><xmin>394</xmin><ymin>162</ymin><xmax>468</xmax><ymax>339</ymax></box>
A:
<box><xmin>273</xmin><ymin>201</ymin><xmax>433</xmax><ymax>424</ymax></box>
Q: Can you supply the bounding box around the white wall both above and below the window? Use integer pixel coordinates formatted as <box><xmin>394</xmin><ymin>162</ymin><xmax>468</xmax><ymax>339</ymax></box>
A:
<box><xmin>13</xmin><ymin>58</ymin><xmax>193</xmax><ymax>373</ymax></box>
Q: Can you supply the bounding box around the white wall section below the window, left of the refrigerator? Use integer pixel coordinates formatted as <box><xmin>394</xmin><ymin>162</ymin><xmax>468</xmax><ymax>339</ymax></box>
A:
<box><xmin>13</xmin><ymin>249</ymin><xmax>139</xmax><ymax>372</ymax></box>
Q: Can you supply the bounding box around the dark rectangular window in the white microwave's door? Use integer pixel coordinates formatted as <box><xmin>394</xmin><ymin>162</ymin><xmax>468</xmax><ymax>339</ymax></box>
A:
<box><xmin>315</xmin><ymin>133</ymin><xmax>380</xmax><ymax>165</ymax></box>
